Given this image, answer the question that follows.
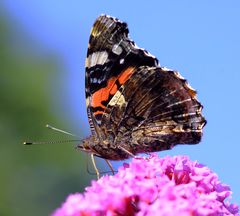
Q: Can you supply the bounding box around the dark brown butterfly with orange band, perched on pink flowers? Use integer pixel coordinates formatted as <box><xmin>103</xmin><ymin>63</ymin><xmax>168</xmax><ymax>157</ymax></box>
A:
<box><xmin>78</xmin><ymin>15</ymin><xmax>206</xmax><ymax>160</ymax></box>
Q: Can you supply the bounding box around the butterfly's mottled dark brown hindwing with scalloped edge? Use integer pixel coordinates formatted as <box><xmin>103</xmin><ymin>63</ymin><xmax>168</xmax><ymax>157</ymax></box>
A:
<box><xmin>102</xmin><ymin>67</ymin><xmax>205</xmax><ymax>154</ymax></box>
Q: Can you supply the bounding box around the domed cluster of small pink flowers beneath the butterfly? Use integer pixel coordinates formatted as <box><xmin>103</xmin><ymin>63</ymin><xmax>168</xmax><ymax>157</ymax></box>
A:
<box><xmin>52</xmin><ymin>154</ymin><xmax>239</xmax><ymax>216</ymax></box>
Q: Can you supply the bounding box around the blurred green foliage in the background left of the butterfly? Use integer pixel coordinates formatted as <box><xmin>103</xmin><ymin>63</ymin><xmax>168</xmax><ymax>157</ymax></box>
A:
<box><xmin>0</xmin><ymin>7</ymin><xmax>93</xmax><ymax>216</ymax></box>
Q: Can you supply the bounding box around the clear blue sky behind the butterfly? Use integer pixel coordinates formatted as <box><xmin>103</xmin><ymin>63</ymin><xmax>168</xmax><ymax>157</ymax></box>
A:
<box><xmin>4</xmin><ymin>0</ymin><xmax>240</xmax><ymax>204</ymax></box>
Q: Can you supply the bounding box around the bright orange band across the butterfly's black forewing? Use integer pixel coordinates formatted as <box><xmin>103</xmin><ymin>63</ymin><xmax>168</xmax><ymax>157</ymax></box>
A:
<box><xmin>91</xmin><ymin>67</ymin><xmax>134</xmax><ymax>112</ymax></box>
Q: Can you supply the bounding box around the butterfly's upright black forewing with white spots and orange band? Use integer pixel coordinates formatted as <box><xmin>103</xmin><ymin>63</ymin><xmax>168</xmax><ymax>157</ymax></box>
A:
<box><xmin>86</xmin><ymin>15</ymin><xmax>158</xmax><ymax>130</ymax></box>
